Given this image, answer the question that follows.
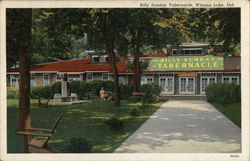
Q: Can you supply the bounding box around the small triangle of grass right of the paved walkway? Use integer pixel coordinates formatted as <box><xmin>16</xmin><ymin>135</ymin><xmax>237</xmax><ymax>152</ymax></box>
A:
<box><xmin>211</xmin><ymin>102</ymin><xmax>241</xmax><ymax>127</ymax></box>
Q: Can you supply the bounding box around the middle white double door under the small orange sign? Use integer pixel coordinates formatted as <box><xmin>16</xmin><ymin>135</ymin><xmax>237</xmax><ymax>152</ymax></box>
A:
<box><xmin>179</xmin><ymin>77</ymin><xmax>195</xmax><ymax>94</ymax></box>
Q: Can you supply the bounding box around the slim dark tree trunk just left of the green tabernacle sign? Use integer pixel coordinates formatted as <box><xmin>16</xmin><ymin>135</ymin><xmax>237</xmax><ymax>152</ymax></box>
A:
<box><xmin>133</xmin><ymin>29</ymin><xmax>142</xmax><ymax>92</ymax></box>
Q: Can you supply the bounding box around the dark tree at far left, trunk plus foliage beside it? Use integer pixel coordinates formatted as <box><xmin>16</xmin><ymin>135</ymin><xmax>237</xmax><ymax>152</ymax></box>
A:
<box><xmin>6</xmin><ymin>9</ymin><xmax>32</xmax><ymax>152</ymax></box>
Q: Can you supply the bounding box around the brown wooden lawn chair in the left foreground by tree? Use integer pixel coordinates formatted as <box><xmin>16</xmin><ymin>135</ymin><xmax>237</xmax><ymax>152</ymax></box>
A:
<box><xmin>16</xmin><ymin>114</ymin><xmax>64</xmax><ymax>153</ymax></box>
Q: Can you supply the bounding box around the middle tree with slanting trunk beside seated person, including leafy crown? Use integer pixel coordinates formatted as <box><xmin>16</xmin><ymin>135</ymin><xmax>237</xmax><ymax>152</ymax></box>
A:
<box><xmin>87</xmin><ymin>9</ymin><xmax>127</xmax><ymax>106</ymax></box>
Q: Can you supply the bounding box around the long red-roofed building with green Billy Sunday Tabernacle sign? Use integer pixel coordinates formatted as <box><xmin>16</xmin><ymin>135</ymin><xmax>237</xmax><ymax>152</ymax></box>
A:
<box><xmin>7</xmin><ymin>43</ymin><xmax>241</xmax><ymax>95</ymax></box>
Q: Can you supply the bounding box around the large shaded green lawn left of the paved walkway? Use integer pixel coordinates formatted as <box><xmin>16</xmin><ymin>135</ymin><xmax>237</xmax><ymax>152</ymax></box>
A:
<box><xmin>7</xmin><ymin>99</ymin><xmax>162</xmax><ymax>153</ymax></box>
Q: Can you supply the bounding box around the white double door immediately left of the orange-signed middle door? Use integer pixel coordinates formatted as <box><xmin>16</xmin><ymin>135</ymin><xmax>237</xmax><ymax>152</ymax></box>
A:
<box><xmin>159</xmin><ymin>77</ymin><xmax>174</xmax><ymax>94</ymax></box>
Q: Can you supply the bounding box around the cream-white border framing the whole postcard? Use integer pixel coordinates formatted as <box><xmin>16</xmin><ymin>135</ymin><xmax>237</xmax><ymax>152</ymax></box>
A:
<box><xmin>0</xmin><ymin>0</ymin><xmax>250</xmax><ymax>161</ymax></box>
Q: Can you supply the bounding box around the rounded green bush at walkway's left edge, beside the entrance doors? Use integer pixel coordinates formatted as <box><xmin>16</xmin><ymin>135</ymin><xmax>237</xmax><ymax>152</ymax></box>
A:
<box><xmin>140</xmin><ymin>83</ymin><xmax>161</xmax><ymax>103</ymax></box>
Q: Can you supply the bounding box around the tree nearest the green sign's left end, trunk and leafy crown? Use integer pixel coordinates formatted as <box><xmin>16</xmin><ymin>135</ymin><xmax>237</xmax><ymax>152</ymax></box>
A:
<box><xmin>127</xmin><ymin>9</ymin><xmax>186</xmax><ymax>91</ymax></box>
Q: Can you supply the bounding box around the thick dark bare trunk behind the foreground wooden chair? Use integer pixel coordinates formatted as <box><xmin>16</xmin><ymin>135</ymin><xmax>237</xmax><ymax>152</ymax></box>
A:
<box><xmin>17</xmin><ymin>9</ymin><xmax>32</xmax><ymax>152</ymax></box>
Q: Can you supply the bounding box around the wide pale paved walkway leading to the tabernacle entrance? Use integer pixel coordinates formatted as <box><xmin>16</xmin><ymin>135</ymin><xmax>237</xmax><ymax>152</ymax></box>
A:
<box><xmin>115</xmin><ymin>100</ymin><xmax>241</xmax><ymax>153</ymax></box>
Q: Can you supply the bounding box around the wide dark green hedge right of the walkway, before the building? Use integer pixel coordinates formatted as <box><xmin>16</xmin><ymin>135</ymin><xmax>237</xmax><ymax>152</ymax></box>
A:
<box><xmin>206</xmin><ymin>83</ymin><xmax>241</xmax><ymax>104</ymax></box>
